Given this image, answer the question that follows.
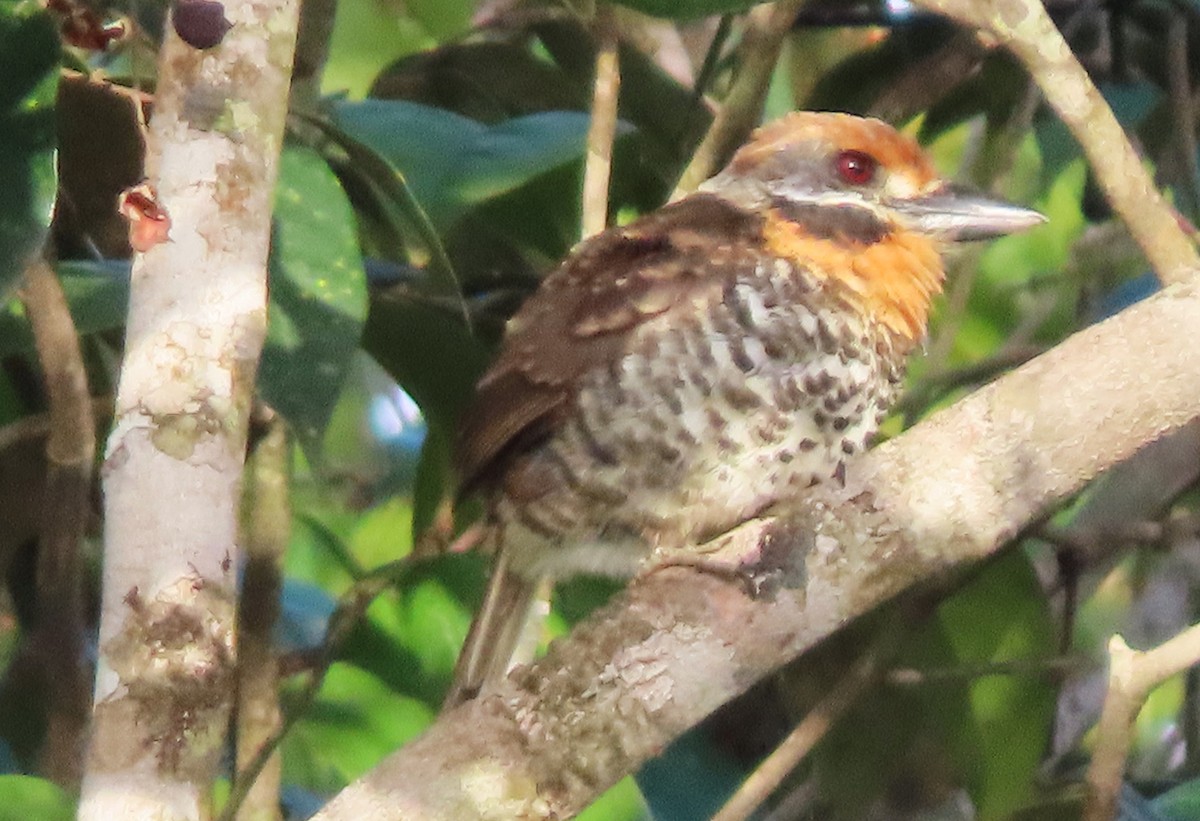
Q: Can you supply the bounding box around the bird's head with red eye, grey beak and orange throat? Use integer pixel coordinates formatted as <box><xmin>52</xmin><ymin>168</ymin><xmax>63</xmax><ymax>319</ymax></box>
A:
<box><xmin>701</xmin><ymin>112</ymin><xmax>1044</xmax><ymax>341</ymax></box>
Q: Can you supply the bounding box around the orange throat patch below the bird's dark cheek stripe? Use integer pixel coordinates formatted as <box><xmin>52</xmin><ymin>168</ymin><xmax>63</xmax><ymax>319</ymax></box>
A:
<box><xmin>762</xmin><ymin>211</ymin><xmax>946</xmax><ymax>346</ymax></box>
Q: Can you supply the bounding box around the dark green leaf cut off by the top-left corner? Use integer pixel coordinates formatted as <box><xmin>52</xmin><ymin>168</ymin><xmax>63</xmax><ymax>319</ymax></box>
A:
<box><xmin>0</xmin><ymin>0</ymin><xmax>61</xmax><ymax>299</ymax></box>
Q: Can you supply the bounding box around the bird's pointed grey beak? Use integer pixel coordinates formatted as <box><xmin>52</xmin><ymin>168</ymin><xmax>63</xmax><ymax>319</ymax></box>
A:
<box><xmin>890</xmin><ymin>184</ymin><xmax>1046</xmax><ymax>242</ymax></box>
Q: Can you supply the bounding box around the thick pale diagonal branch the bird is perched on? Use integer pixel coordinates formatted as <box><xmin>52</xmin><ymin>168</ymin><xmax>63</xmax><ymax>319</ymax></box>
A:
<box><xmin>317</xmin><ymin>272</ymin><xmax>1200</xmax><ymax>821</ymax></box>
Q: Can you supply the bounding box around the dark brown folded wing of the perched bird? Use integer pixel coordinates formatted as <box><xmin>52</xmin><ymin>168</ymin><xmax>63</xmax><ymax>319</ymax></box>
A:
<box><xmin>456</xmin><ymin>194</ymin><xmax>761</xmax><ymax>491</ymax></box>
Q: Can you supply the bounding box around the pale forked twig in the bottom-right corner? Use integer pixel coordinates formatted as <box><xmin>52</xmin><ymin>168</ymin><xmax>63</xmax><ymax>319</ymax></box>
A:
<box><xmin>1082</xmin><ymin>624</ymin><xmax>1200</xmax><ymax>821</ymax></box>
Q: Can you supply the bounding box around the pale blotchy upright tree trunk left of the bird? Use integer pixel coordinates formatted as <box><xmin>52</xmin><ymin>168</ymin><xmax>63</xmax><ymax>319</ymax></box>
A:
<box><xmin>79</xmin><ymin>0</ymin><xmax>299</xmax><ymax>821</ymax></box>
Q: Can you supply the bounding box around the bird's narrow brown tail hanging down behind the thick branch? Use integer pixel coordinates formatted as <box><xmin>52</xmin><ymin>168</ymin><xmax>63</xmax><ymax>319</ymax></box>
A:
<box><xmin>442</xmin><ymin>547</ymin><xmax>536</xmax><ymax>709</ymax></box>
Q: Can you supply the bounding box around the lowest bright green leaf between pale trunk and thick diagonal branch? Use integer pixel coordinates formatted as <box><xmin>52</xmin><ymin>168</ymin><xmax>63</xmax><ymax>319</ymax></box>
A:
<box><xmin>283</xmin><ymin>663</ymin><xmax>434</xmax><ymax>792</ymax></box>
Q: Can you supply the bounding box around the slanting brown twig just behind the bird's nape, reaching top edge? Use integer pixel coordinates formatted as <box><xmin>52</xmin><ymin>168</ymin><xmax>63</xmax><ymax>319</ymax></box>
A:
<box><xmin>671</xmin><ymin>0</ymin><xmax>804</xmax><ymax>199</ymax></box>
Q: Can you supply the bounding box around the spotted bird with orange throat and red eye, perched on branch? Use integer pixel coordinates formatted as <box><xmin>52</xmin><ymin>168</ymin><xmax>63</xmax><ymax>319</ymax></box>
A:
<box><xmin>445</xmin><ymin>112</ymin><xmax>1044</xmax><ymax>707</ymax></box>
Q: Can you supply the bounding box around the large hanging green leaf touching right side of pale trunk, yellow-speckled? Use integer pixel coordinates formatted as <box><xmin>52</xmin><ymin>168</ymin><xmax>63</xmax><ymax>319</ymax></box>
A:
<box><xmin>258</xmin><ymin>148</ymin><xmax>367</xmax><ymax>447</ymax></box>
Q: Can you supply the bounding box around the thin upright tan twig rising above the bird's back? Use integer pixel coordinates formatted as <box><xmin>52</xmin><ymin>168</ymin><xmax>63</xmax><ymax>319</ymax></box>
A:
<box><xmin>581</xmin><ymin>2</ymin><xmax>620</xmax><ymax>239</ymax></box>
